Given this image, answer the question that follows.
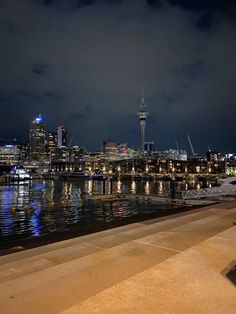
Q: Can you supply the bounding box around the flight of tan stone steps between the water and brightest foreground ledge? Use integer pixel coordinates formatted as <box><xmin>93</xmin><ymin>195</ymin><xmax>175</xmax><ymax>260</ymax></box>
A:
<box><xmin>0</xmin><ymin>204</ymin><xmax>235</xmax><ymax>314</ymax></box>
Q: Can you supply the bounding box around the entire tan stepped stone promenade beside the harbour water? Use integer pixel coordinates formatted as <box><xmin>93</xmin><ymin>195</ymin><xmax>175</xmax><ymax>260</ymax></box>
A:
<box><xmin>0</xmin><ymin>201</ymin><xmax>236</xmax><ymax>314</ymax></box>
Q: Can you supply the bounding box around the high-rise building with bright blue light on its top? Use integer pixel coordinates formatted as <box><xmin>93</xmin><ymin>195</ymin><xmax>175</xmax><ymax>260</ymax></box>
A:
<box><xmin>29</xmin><ymin>115</ymin><xmax>46</xmax><ymax>160</ymax></box>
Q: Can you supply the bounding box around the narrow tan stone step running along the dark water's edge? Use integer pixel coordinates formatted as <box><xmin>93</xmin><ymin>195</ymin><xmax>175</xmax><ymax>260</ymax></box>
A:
<box><xmin>0</xmin><ymin>207</ymin><xmax>213</xmax><ymax>271</ymax></box>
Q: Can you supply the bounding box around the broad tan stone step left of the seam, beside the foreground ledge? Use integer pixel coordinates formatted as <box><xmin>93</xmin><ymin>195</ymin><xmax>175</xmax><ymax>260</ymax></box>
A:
<box><xmin>0</xmin><ymin>236</ymin><xmax>177</xmax><ymax>314</ymax></box>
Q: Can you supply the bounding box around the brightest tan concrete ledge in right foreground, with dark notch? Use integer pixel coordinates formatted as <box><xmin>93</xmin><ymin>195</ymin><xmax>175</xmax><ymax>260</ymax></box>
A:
<box><xmin>62</xmin><ymin>227</ymin><xmax>236</xmax><ymax>314</ymax></box>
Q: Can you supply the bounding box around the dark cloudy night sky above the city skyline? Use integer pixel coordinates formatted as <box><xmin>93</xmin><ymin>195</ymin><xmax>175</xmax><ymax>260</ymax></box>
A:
<box><xmin>0</xmin><ymin>0</ymin><xmax>236</xmax><ymax>153</ymax></box>
